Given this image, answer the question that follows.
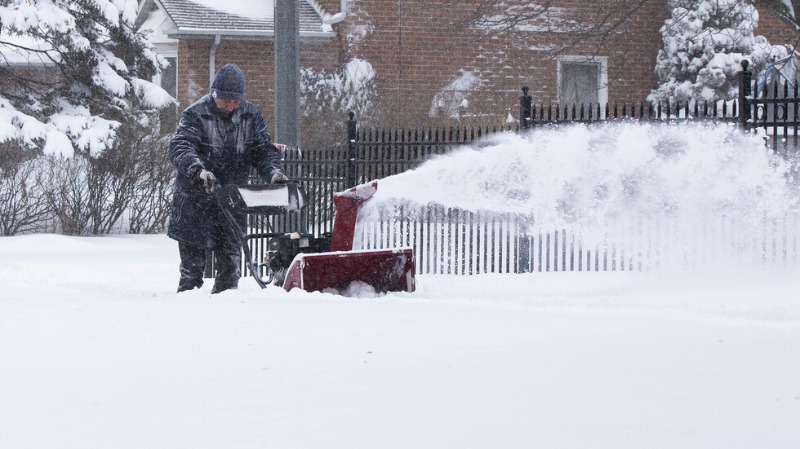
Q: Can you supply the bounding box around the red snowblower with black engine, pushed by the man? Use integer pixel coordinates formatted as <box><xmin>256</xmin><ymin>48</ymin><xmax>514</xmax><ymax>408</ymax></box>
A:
<box><xmin>214</xmin><ymin>181</ymin><xmax>415</xmax><ymax>293</ymax></box>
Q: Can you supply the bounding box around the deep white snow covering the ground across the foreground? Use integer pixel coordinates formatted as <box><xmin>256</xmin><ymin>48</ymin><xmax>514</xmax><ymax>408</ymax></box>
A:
<box><xmin>0</xmin><ymin>235</ymin><xmax>800</xmax><ymax>449</ymax></box>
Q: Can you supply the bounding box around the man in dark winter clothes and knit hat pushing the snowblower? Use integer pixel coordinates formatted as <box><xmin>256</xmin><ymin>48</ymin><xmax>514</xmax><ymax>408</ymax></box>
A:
<box><xmin>167</xmin><ymin>64</ymin><xmax>288</xmax><ymax>293</ymax></box>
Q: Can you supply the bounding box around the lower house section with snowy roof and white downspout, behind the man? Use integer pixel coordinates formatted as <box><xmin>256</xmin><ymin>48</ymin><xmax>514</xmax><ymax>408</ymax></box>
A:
<box><xmin>136</xmin><ymin>0</ymin><xmax>340</xmax><ymax>131</ymax></box>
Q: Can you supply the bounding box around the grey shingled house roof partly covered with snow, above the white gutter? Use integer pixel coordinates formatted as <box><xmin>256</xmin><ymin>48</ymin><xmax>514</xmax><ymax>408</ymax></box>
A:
<box><xmin>144</xmin><ymin>0</ymin><xmax>334</xmax><ymax>37</ymax></box>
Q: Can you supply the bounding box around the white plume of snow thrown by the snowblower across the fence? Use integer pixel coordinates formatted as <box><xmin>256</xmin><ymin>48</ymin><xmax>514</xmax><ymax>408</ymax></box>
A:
<box><xmin>359</xmin><ymin>122</ymin><xmax>800</xmax><ymax>272</ymax></box>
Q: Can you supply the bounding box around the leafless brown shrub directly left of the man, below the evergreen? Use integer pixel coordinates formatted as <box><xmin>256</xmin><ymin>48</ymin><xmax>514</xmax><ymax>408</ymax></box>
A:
<box><xmin>34</xmin><ymin>111</ymin><xmax>174</xmax><ymax>235</ymax></box>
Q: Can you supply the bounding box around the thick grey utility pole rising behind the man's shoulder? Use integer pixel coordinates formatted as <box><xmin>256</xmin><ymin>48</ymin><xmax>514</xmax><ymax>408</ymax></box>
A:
<box><xmin>273</xmin><ymin>0</ymin><xmax>300</xmax><ymax>148</ymax></box>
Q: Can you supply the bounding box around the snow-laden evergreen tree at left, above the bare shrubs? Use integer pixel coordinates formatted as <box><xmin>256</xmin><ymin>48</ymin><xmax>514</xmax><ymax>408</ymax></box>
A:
<box><xmin>0</xmin><ymin>0</ymin><xmax>173</xmax><ymax>157</ymax></box>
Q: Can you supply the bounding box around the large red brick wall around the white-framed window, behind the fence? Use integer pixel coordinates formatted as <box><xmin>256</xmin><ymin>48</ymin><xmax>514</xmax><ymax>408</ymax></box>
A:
<box><xmin>332</xmin><ymin>0</ymin><xmax>668</xmax><ymax>124</ymax></box>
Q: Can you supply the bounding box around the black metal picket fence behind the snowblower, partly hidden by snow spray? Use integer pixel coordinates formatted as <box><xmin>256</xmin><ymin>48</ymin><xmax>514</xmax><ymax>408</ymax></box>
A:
<box><xmin>242</xmin><ymin>63</ymin><xmax>800</xmax><ymax>274</ymax></box>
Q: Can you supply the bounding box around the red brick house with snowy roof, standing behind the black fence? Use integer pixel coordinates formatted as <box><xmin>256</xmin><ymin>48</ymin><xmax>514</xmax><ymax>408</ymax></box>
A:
<box><xmin>138</xmin><ymin>0</ymin><xmax>797</xmax><ymax>135</ymax></box>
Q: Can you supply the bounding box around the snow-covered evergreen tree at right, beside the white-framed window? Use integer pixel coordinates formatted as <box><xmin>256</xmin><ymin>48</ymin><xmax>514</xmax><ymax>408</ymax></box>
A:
<box><xmin>648</xmin><ymin>0</ymin><xmax>787</xmax><ymax>105</ymax></box>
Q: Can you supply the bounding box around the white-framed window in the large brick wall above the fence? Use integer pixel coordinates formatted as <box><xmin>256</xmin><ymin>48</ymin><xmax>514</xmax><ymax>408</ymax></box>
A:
<box><xmin>558</xmin><ymin>56</ymin><xmax>608</xmax><ymax>112</ymax></box>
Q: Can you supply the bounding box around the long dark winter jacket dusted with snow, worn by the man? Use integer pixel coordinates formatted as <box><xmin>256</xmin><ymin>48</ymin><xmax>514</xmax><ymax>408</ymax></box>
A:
<box><xmin>167</xmin><ymin>95</ymin><xmax>283</xmax><ymax>248</ymax></box>
